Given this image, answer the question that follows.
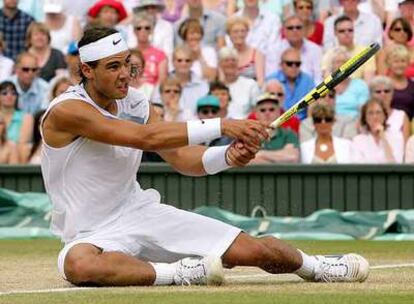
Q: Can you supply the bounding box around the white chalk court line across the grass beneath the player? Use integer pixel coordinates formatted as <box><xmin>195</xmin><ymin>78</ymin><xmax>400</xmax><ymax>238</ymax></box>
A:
<box><xmin>0</xmin><ymin>263</ymin><xmax>414</xmax><ymax>296</ymax></box>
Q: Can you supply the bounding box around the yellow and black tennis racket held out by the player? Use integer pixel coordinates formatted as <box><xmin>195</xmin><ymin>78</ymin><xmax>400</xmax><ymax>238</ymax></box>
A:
<box><xmin>271</xmin><ymin>43</ymin><xmax>380</xmax><ymax>128</ymax></box>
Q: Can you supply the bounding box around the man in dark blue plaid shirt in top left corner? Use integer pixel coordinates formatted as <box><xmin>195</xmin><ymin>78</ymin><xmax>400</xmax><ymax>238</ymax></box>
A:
<box><xmin>0</xmin><ymin>0</ymin><xmax>34</xmax><ymax>60</ymax></box>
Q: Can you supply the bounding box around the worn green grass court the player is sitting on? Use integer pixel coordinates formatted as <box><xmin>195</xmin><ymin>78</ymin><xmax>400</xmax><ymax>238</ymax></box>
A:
<box><xmin>0</xmin><ymin>240</ymin><xmax>414</xmax><ymax>304</ymax></box>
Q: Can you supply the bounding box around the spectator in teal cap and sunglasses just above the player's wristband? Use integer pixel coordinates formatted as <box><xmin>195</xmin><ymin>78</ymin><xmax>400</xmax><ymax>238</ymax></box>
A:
<box><xmin>197</xmin><ymin>95</ymin><xmax>233</xmax><ymax>147</ymax></box>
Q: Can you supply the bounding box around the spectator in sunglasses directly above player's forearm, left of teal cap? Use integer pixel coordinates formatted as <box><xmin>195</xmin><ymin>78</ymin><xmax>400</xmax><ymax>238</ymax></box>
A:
<box><xmin>160</xmin><ymin>77</ymin><xmax>194</xmax><ymax>121</ymax></box>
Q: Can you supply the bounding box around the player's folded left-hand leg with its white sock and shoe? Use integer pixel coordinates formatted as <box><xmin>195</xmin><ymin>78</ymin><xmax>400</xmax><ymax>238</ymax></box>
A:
<box><xmin>62</xmin><ymin>241</ymin><xmax>223</xmax><ymax>286</ymax></box>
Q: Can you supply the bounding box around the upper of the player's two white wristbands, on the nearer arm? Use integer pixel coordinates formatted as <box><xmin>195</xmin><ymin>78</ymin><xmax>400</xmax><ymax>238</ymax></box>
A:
<box><xmin>187</xmin><ymin>118</ymin><xmax>221</xmax><ymax>146</ymax></box>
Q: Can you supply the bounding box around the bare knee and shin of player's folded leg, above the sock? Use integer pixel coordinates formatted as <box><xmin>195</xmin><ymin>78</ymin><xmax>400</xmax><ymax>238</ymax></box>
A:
<box><xmin>64</xmin><ymin>243</ymin><xmax>155</xmax><ymax>286</ymax></box>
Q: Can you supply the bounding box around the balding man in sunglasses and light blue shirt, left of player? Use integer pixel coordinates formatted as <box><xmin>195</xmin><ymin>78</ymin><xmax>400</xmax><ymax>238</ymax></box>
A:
<box><xmin>9</xmin><ymin>52</ymin><xmax>49</xmax><ymax>115</ymax></box>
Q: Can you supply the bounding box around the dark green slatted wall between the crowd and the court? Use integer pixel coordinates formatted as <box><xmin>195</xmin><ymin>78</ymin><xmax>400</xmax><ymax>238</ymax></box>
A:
<box><xmin>0</xmin><ymin>164</ymin><xmax>414</xmax><ymax>216</ymax></box>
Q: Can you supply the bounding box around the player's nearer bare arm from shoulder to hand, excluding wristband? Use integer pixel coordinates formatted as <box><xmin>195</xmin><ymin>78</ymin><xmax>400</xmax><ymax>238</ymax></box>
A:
<box><xmin>44</xmin><ymin>100</ymin><xmax>267</xmax><ymax>151</ymax></box>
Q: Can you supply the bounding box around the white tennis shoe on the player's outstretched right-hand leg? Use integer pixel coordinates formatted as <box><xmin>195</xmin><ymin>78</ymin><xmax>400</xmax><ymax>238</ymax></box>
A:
<box><xmin>314</xmin><ymin>253</ymin><xmax>369</xmax><ymax>282</ymax></box>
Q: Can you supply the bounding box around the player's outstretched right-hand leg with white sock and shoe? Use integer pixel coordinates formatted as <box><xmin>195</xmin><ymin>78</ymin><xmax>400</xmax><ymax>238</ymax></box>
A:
<box><xmin>222</xmin><ymin>233</ymin><xmax>369</xmax><ymax>282</ymax></box>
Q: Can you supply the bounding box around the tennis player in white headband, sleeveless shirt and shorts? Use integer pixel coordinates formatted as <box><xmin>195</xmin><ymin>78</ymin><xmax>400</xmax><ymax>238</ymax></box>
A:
<box><xmin>41</xmin><ymin>28</ymin><xmax>369</xmax><ymax>286</ymax></box>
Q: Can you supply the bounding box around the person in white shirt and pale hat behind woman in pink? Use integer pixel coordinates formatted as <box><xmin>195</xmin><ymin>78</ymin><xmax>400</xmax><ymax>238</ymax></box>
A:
<box><xmin>128</xmin><ymin>0</ymin><xmax>174</xmax><ymax>60</ymax></box>
